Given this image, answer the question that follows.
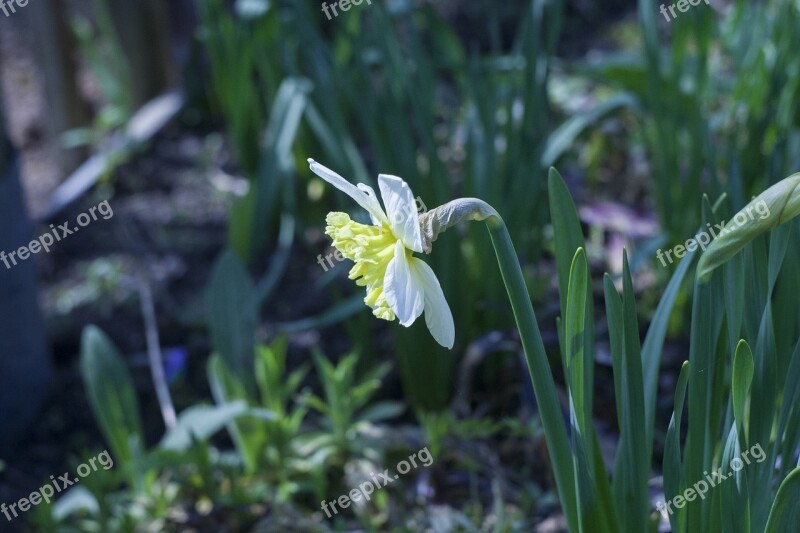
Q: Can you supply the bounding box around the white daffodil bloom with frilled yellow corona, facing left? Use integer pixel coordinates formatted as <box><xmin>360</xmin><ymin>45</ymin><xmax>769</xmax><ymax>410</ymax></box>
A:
<box><xmin>308</xmin><ymin>159</ymin><xmax>455</xmax><ymax>348</ymax></box>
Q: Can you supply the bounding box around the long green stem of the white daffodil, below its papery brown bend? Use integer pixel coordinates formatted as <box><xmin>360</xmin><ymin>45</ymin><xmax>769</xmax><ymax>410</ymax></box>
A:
<box><xmin>485</xmin><ymin>215</ymin><xmax>578</xmax><ymax>531</ymax></box>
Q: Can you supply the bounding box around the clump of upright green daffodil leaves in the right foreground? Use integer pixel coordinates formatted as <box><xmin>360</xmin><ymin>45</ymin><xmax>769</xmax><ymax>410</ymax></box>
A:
<box><xmin>490</xmin><ymin>171</ymin><xmax>800</xmax><ymax>531</ymax></box>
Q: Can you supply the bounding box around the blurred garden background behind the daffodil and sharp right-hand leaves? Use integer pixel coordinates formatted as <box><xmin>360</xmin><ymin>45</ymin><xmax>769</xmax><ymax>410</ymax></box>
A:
<box><xmin>0</xmin><ymin>0</ymin><xmax>800</xmax><ymax>531</ymax></box>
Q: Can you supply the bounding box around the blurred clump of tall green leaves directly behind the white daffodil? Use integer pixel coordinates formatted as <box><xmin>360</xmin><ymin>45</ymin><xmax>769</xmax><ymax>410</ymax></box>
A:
<box><xmin>199</xmin><ymin>0</ymin><xmax>590</xmax><ymax>408</ymax></box>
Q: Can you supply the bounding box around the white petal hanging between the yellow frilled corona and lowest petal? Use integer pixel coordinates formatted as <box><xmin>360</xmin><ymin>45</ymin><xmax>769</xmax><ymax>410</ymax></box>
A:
<box><xmin>383</xmin><ymin>241</ymin><xmax>425</xmax><ymax>327</ymax></box>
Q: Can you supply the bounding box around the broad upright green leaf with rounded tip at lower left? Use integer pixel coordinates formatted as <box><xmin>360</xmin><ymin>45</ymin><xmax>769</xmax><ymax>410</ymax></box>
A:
<box><xmin>80</xmin><ymin>326</ymin><xmax>144</xmax><ymax>464</ymax></box>
